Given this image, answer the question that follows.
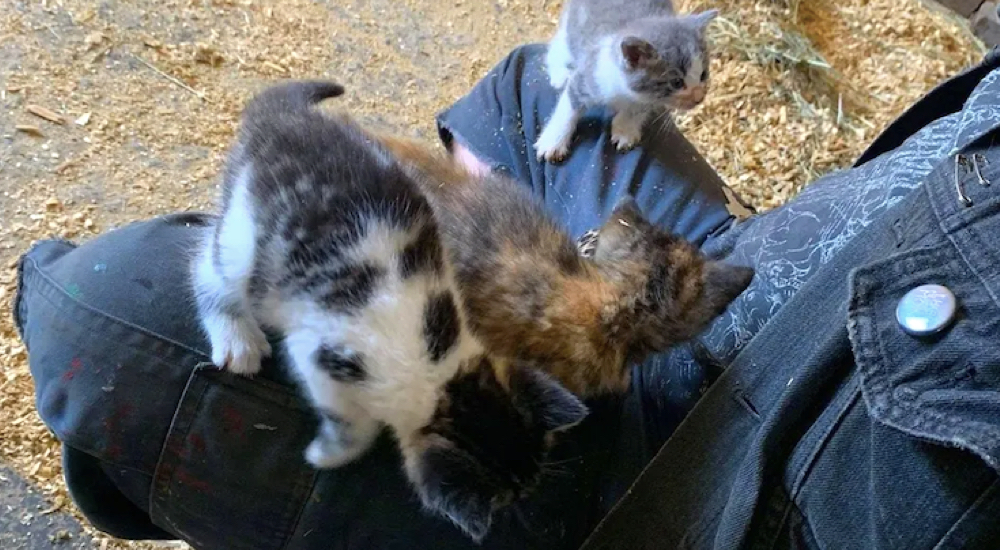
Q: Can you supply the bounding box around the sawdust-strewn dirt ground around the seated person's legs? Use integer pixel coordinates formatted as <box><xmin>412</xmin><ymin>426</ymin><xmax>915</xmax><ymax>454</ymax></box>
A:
<box><xmin>0</xmin><ymin>0</ymin><xmax>982</xmax><ymax>548</ymax></box>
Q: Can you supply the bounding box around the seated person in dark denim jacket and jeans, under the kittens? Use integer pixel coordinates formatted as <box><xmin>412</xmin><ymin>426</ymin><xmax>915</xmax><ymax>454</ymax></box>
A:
<box><xmin>15</xmin><ymin>46</ymin><xmax>1000</xmax><ymax>550</ymax></box>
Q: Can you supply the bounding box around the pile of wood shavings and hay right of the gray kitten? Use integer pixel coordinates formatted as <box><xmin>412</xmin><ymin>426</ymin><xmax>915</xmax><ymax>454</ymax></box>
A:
<box><xmin>680</xmin><ymin>0</ymin><xmax>985</xmax><ymax>208</ymax></box>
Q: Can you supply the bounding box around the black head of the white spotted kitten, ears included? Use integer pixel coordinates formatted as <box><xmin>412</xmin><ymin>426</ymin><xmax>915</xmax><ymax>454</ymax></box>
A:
<box><xmin>419</xmin><ymin>357</ymin><xmax>587</xmax><ymax>541</ymax></box>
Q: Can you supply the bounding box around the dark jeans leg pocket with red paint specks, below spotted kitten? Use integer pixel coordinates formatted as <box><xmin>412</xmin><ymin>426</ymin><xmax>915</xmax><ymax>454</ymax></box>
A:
<box><xmin>150</xmin><ymin>365</ymin><xmax>316</xmax><ymax>550</ymax></box>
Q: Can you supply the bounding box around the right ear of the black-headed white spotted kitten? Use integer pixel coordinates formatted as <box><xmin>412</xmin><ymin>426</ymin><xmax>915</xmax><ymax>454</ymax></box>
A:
<box><xmin>510</xmin><ymin>368</ymin><xmax>589</xmax><ymax>431</ymax></box>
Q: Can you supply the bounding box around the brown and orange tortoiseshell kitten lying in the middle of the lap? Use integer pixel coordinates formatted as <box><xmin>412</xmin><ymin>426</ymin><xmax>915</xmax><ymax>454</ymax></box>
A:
<box><xmin>378</xmin><ymin>135</ymin><xmax>754</xmax><ymax>402</ymax></box>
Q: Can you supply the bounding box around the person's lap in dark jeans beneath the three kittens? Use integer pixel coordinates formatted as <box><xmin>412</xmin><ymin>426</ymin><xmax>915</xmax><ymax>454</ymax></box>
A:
<box><xmin>11</xmin><ymin>42</ymin><xmax>952</xmax><ymax>548</ymax></box>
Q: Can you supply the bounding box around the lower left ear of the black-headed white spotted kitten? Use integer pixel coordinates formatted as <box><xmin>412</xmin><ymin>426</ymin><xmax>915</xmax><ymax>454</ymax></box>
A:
<box><xmin>417</xmin><ymin>445</ymin><xmax>500</xmax><ymax>542</ymax></box>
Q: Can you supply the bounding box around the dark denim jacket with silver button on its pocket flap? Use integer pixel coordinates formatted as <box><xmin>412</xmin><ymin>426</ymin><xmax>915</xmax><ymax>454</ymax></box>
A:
<box><xmin>584</xmin><ymin>49</ymin><xmax>1000</xmax><ymax>550</ymax></box>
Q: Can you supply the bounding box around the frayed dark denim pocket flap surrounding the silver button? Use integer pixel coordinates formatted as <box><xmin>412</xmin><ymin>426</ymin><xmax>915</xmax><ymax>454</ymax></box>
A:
<box><xmin>848</xmin><ymin>243</ymin><xmax>1000</xmax><ymax>469</ymax></box>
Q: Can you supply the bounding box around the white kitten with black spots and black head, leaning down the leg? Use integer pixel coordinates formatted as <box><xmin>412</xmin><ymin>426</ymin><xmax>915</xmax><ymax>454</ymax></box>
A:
<box><xmin>192</xmin><ymin>82</ymin><xmax>586</xmax><ymax>540</ymax></box>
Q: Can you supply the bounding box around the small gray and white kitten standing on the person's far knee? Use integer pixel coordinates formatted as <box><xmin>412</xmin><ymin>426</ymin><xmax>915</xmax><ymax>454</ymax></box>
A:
<box><xmin>535</xmin><ymin>0</ymin><xmax>718</xmax><ymax>161</ymax></box>
